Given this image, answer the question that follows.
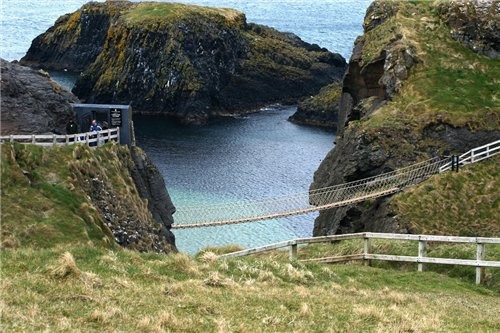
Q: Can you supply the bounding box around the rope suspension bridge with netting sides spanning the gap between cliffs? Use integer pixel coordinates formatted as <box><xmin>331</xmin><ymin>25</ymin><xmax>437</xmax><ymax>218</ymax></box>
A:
<box><xmin>172</xmin><ymin>140</ymin><xmax>500</xmax><ymax>229</ymax></box>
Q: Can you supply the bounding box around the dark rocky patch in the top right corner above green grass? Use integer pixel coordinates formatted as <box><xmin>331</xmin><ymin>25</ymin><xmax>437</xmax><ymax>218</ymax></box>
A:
<box><xmin>440</xmin><ymin>0</ymin><xmax>500</xmax><ymax>58</ymax></box>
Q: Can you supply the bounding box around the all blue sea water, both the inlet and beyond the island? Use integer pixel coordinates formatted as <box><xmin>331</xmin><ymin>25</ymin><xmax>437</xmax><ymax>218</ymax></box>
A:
<box><xmin>0</xmin><ymin>0</ymin><xmax>371</xmax><ymax>253</ymax></box>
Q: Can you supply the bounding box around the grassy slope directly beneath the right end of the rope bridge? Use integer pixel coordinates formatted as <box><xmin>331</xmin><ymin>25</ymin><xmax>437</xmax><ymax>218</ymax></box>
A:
<box><xmin>390</xmin><ymin>155</ymin><xmax>500</xmax><ymax>237</ymax></box>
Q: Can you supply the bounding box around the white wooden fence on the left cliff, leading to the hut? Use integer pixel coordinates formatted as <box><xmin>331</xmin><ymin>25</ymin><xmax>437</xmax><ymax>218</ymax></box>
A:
<box><xmin>0</xmin><ymin>127</ymin><xmax>120</xmax><ymax>146</ymax></box>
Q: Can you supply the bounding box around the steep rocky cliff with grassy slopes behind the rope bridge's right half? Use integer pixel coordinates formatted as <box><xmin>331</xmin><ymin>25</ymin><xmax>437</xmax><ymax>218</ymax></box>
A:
<box><xmin>311</xmin><ymin>1</ymin><xmax>500</xmax><ymax>235</ymax></box>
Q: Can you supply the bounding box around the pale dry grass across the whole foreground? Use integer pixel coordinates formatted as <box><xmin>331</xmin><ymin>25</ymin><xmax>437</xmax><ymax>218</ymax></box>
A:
<box><xmin>0</xmin><ymin>246</ymin><xmax>500</xmax><ymax>332</ymax></box>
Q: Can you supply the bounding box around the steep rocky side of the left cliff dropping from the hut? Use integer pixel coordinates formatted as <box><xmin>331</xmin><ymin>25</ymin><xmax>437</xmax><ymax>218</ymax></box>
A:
<box><xmin>71</xmin><ymin>145</ymin><xmax>177</xmax><ymax>253</ymax></box>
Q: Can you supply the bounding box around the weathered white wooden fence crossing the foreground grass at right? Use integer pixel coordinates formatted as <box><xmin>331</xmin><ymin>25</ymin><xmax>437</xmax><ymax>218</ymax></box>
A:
<box><xmin>219</xmin><ymin>232</ymin><xmax>500</xmax><ymax>284</ymax></box>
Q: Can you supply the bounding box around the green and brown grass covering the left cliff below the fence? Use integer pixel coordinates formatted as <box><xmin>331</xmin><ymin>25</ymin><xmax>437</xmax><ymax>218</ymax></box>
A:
<box><xmin>1</xmin><ymin>143</ymin><xmax>152</xmax><ymax>248</ymax></box>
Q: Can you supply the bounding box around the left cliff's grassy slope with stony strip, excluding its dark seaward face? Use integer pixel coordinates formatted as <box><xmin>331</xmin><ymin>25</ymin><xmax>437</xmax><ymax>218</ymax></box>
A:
<box><xmin>1</xmin><ymin>143</ymin><xmax>175</xmax><ymax>252</ymax></box>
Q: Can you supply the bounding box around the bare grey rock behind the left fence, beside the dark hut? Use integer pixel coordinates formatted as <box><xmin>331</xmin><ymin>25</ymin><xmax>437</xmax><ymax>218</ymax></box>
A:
<box><xmin>0</xmin><ymin>59</ymin><xmax>78</xmax><ymax>135</ymax></box>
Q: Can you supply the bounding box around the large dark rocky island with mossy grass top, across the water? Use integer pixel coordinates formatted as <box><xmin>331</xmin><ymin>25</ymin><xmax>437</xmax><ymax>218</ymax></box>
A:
<box><xmin>21</xmin><ymin>1</ymin><xmax>345</xmax><ymax>124</ymax></box>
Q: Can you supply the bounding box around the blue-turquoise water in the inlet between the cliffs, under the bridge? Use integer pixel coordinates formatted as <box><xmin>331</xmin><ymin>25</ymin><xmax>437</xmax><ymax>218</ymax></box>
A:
<box><xmin>134</xmin><ymin>106</ymin><xmax>334</xmax><ymax>254</ymax></box>
